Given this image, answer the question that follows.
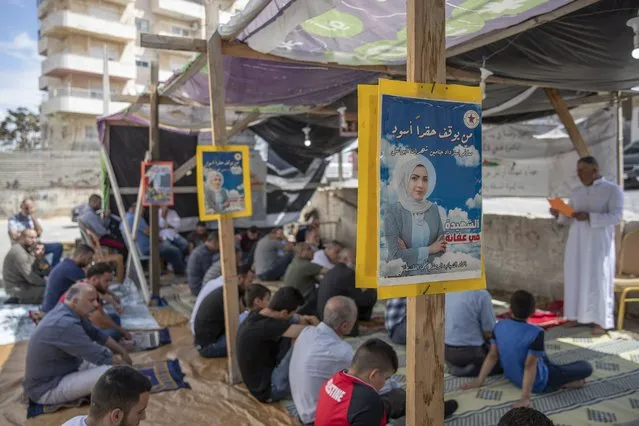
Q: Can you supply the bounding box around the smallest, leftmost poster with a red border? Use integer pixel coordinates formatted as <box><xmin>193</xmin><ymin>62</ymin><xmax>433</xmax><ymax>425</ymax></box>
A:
<box><xmin>141</xmin><ymin>161</ymin><xmax>173</xmax><ymax>206</ymax></box>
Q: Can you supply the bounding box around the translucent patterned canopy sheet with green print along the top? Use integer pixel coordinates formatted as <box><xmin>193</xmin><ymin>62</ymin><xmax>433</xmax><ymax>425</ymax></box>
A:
<box><xmin>221</xmin><ymin>0</ymin><xmax>571</xmax><ymax>65</ymax></box>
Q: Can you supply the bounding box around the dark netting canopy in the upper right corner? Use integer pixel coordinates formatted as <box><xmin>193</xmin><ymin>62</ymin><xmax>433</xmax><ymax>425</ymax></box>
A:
<box><xmin>448</xmin><ymin>0</ymin><xmax>639</xmax><ymax>91</ymax></box>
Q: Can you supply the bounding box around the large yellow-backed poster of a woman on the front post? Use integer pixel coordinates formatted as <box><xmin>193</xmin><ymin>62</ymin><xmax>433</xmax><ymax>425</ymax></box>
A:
<box><xmin>356</xmin><ymin>80</ymin><xmax>486</xmax><ymax>299</ymax></box>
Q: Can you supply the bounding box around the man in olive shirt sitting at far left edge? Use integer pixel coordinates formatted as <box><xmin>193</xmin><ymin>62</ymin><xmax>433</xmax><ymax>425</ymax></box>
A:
<box><xmin>2</xmin><ymin>228</ymin><xmax>45</xmax><ymax>305</ymax></box>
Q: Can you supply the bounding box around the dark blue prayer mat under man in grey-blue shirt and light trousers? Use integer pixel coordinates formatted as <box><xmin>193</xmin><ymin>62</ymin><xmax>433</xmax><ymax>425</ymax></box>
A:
<box><xmin>24</xmin><ymin>359</ymin><xmax>191</xmax><ymax>419</ymax></box>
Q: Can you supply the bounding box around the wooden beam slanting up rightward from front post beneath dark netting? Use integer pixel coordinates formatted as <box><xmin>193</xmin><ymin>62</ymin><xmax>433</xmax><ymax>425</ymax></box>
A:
<box><xmin>446</xmin><ymin>0</ymin><xmax>600</xmax><ymax>58</ymax></box>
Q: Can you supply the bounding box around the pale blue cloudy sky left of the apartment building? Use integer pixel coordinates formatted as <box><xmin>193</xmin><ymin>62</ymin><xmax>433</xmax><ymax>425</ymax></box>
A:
<box><xmin>0</xmin><ymin>0</ymin><xmax>44</xmax><ymax>118</ymax></box>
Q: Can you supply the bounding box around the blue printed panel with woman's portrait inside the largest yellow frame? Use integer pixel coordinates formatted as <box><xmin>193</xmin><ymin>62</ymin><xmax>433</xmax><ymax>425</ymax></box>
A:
<box><xmin>378</xmin><ymin>94</ymin><xmax>482</xmax><ymax>285</ymax></box>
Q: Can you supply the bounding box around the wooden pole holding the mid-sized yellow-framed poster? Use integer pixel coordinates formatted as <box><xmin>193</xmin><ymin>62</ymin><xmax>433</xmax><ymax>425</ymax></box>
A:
<box><xmin>206</xmin><ymin>2</ymin><xmax>241</xmax><ymax>384</ymax></box>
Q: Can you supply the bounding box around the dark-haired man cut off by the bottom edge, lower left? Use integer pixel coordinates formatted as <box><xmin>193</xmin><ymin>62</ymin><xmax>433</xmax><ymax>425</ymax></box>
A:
<box><xmin>62</xmin><ymin>365</ymin><xmax>151</xmax><ymax>426</ymax></box>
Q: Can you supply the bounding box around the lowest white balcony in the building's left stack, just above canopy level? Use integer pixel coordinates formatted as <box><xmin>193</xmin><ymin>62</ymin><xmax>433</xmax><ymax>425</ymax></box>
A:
<box><xmin>40</xmin><ymin>88</ymin><xmax>129</xmax><ymax>117</ymax></box>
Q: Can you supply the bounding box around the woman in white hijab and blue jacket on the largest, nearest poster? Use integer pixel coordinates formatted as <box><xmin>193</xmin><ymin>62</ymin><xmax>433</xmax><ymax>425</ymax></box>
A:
<box><xmin>384</xmin><ymin>155</ymin><xmax>446</xmax><ymax>276</ymax></box>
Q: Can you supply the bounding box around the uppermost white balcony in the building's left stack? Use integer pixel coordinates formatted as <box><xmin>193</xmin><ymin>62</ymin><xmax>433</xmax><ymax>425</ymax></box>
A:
<box><xmin>40</xmin><ymin>10</ymin><xmax>136</xmax><ymax>42</ymax></box>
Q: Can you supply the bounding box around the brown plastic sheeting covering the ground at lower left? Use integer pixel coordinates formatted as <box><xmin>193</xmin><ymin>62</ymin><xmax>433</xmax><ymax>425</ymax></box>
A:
<box><xmin>0</xmin><ymin>326</ymin><xmax>297</xmax><ymax>426</ymax></box>
